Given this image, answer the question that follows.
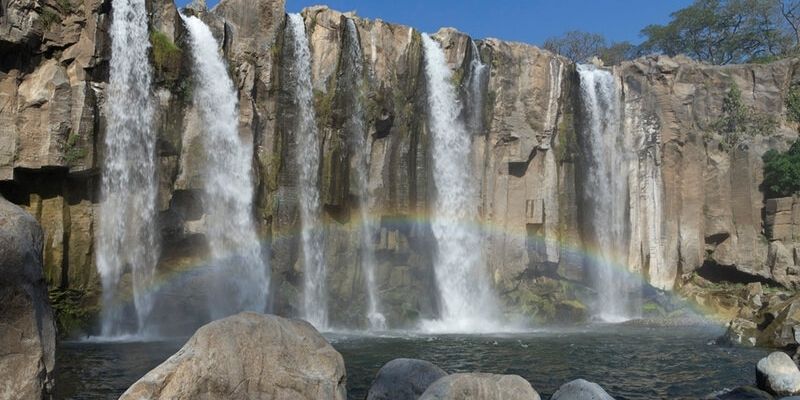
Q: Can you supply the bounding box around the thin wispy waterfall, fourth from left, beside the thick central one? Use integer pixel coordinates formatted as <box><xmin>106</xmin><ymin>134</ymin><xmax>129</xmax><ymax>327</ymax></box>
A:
<box><xmin>344</xmin><ymin>18</ymin><xmax>386</xmax><ymax>331</ymax></box>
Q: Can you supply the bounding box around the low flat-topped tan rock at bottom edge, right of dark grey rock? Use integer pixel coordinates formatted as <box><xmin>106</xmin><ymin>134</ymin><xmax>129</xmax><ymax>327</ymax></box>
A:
<box><xmin>419</xmin><ymin>374</ymin><xmax>541</xmax><ymax>400</ymax></box>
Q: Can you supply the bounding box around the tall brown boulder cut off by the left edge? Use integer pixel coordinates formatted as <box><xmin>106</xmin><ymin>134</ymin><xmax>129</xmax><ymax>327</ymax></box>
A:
<box><xmin>0</xmin><ymin>197</ymin><xmax>56</xmax><ymax>399</ymax></box>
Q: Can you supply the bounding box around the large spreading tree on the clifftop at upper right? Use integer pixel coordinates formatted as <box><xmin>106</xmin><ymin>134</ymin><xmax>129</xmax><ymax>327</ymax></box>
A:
<box><xmin>639</xmin><ymin>0</ymin><xmax>798</xmax><ymax>64</ymax></box>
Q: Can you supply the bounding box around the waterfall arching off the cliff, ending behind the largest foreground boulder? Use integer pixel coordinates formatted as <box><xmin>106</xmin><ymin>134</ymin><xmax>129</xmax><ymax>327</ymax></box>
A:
<box><xmin>181</xmin><ymin>15</ymin><xmax>269</xmax><ymax>319</ymax></box>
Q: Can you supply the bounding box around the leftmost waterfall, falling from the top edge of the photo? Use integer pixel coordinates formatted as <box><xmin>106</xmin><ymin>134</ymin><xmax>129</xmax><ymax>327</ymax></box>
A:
<box><xmin>96</xmin><ymin>0</ymin><xmax>159</xmax><ymax>336</ymax></box>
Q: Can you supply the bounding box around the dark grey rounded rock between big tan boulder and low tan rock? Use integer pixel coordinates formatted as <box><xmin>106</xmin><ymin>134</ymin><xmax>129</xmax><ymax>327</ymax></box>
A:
<box><xmin>367</xmin><ymin>358</ymin><xmax>447</xmax><ymax>400</ymax></box>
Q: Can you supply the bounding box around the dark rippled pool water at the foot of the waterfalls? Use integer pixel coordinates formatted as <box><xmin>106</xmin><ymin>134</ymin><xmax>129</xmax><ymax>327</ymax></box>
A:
<box><xmin>56</xmin><ymin>326</ymin><xmax>768</xmax><ymax>400</ymax></box>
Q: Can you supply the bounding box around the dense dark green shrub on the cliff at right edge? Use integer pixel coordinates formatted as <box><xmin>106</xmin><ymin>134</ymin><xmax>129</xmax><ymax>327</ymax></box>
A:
<box><xmin>763</xmin><ymin>140</ymin><xmax>800</xmax><ymax>197</ymax></box>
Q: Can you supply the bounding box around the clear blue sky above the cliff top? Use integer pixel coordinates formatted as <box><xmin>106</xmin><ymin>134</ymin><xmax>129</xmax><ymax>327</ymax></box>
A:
<box><xmin>177</xmin><ymin>0</ymin><xmax>691</xmax><ymax>44</ymax></box>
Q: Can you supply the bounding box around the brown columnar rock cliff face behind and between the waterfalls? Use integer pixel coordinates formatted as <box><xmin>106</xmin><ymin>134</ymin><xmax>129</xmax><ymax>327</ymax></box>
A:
<box><xmin>0</xmin><ymin>0</ymin><xmax>800</xmax><ymax>332</ymax></box>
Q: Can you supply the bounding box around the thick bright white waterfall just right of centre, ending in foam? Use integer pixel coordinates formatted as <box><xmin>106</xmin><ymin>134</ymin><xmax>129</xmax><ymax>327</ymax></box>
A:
<box><xmin>422</xmin><ymin>35</ymin><xmax>499</xmax><ymax>332</ymax></box>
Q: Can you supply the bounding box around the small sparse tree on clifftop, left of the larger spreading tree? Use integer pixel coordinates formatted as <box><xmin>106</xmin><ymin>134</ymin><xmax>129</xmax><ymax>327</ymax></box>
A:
<box><xmin>544</xmin><ymin>31</ymin><xmax>635</xmax><ymax>65</ymax></box>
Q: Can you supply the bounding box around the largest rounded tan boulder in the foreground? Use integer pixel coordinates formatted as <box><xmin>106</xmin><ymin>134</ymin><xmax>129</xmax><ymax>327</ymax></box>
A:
<box><xmin>120</xmin><ymin>312</ymin><xmax>346</xmax><ymax>400</ymax></box>
